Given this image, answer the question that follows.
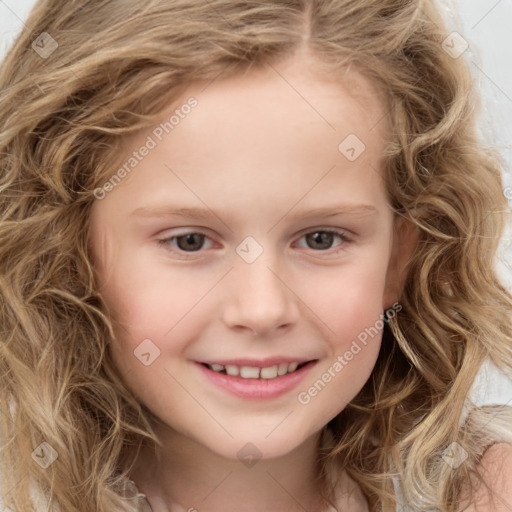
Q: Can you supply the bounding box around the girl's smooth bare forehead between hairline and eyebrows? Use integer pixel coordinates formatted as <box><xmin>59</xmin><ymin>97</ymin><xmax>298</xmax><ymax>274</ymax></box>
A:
<box><xmin>94</xmin><ymin>52</ymin><xmax>388</xmax><ymax>220</ymax></box>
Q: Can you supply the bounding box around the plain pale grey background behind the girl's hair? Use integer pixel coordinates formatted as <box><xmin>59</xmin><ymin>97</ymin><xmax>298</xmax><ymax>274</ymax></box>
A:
<box><xmin>0</xmin><ymin>0</ymin><xmax>512</xmax><ymax>388</ymax></box>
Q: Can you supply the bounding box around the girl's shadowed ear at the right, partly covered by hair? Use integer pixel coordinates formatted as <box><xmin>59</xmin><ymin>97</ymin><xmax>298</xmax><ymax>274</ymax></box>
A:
<box><xmin>382</xmin><ymin>217</ymin><xmax>419</xmax><ymax>309</ymax></box>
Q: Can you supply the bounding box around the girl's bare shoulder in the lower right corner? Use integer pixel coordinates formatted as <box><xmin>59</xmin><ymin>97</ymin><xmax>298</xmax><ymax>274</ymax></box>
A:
<box><xmin>463</xmin><ymin>443</ymin><xmax>512</xmax><ymax>512</ymax></box>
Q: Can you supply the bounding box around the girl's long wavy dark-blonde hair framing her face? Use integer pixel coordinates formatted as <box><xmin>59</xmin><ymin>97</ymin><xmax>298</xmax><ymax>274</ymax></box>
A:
<box><xmin>0</xmin><ymin>0</ymin><xmax>512</xmax><ymax>512</ymax></box>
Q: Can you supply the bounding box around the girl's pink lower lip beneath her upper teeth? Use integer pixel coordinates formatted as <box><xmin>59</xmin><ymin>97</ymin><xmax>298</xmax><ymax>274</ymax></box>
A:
<box><xmin>196</xmin><ymin>361</ymin><xmax>316</xmax><ymax>399</ymax></box>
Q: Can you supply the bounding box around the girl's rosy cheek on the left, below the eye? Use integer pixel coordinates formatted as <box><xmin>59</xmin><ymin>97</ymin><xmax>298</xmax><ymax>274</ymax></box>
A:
<box><xmin>98</xmin><ymin>250</ymin><xmax>208</xmax><ymax>380</ymax></box>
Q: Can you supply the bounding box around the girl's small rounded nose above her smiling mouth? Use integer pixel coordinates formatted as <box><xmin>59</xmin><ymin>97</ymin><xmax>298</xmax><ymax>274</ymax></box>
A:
<box><xmin>223</xmin><ymin>257</ymin><xmax>299</xmax><ymax>336</ymax></box>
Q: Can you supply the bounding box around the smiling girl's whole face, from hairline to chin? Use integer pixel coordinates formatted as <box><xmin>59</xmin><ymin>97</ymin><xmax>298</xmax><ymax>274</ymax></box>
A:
<box><xmin>91</xmin><ymin>55</ymin><xmax>416</xmax><ymax>458</ymax></box>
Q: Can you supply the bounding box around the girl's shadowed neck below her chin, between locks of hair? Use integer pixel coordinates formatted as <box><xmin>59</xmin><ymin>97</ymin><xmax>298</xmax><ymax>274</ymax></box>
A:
<box><xmin>130</xmin><ymin>424</ymin><xmax>328</xmax><ymax>512</ymax></box>
